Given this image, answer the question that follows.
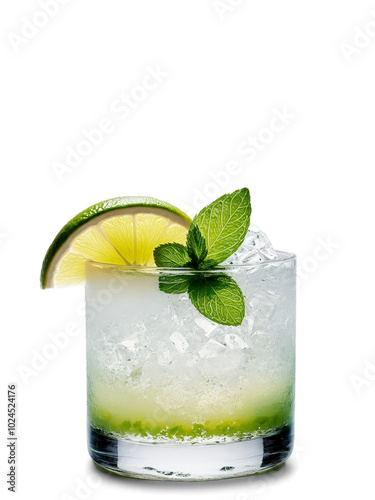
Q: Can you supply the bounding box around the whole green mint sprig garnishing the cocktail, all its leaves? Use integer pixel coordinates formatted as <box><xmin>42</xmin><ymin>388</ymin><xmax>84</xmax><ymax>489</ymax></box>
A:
<box><xmin>154</xmin><ymin>188</ymin><xmax>251</xmax><ymax>326</ymax></box>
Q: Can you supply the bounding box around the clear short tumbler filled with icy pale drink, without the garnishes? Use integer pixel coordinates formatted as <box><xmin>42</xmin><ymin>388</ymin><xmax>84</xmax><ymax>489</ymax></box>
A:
<box><xmin>86</xmin><ymin>252</ymin><xmax>296</xmax><ymax>480</ymax></box>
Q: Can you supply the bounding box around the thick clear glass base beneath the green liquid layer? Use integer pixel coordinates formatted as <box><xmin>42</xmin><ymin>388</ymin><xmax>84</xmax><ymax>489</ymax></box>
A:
<box><xmin>89</xmin><ymin>426</ymin><xmax>293</xmax><ymax>481</ymax></box>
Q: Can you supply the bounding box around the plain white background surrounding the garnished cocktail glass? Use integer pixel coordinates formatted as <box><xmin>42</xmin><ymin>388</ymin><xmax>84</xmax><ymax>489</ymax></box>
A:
<box><xmin>0</xmin><ymin>0</ymin><xmax>375</xmax><ymax>500</ymax></box>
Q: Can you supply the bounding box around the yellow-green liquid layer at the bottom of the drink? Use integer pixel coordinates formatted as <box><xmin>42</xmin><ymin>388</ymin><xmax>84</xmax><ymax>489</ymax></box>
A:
<box><xmin>88</xmin><ymin>376</ymin><xmax>294</xmax><ymax>441</ymax></box>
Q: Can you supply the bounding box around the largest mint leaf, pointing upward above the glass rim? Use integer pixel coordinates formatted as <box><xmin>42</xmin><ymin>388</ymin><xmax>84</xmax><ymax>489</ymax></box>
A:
<box><xmin>193</xmin><ymin>188</ymin><xmax>251</xmax><ymax>264</ymax></box>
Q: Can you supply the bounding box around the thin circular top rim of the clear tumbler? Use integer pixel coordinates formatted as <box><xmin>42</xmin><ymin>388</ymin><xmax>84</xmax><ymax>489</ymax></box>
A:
<box><xmin>86</xmin><ymin>250</ymin><xmax>297</xmax><ymax>274</ymax></box>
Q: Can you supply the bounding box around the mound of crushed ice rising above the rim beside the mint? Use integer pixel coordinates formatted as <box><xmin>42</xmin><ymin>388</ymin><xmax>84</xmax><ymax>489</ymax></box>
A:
<box><xmin>223</xmin><ymin>225</ymin><xmax>278</xmax><ymax>265</ymax></box>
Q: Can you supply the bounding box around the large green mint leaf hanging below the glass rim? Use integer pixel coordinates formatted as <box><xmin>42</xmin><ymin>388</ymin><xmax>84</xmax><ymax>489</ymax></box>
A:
<box><xmin>189</xmin><ymin>274</ymin><xmax>245</xmax><ymax>326</ymax></box>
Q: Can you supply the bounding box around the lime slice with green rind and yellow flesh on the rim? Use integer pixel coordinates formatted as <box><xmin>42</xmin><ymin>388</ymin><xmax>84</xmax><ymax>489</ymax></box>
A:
<box><xmin>40</xmin><ymin>196</ymin><xmax>191</xmax><ymax>288</ymax></box>
